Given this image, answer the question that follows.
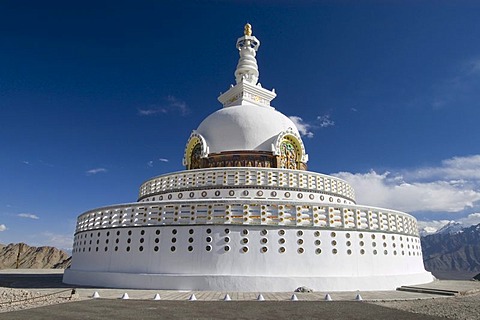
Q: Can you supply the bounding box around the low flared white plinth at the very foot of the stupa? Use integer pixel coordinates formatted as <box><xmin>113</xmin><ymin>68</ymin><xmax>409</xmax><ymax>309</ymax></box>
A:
<box><xmin>63</xmin><ymin>269</ymin><xmax>433</xmax><ymax>292</ymax></box>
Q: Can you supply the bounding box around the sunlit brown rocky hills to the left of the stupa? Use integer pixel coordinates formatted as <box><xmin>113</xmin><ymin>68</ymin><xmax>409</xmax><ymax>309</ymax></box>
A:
<box><xmin>0</xmin><ymin>243</ymin><xmax>69</xmax><ymax>269</ymax></box>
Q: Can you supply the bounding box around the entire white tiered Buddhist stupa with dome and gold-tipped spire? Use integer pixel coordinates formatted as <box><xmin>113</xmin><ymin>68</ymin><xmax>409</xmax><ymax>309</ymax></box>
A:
<box><xmin>63</xmin><ymin>24</ymin><xmax>433</xmax><ymax>292</ymax></box>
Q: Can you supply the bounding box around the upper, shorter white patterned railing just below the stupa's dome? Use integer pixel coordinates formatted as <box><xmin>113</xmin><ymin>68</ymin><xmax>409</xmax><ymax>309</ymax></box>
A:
<box><xmin>139</xmin><ymin>168</ymin><xmax>355</xmax><ymax>201</ymax></box>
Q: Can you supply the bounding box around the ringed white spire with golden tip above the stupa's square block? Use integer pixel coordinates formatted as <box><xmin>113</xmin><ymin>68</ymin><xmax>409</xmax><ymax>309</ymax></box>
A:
<box><xmin>235</xmin><ymin>23</ymin><xmax>260</xmax><ymax>85</ymax></box>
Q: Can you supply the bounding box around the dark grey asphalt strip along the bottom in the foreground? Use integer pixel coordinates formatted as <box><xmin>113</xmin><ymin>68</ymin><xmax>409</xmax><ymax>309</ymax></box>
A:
<box><xmin>0</xmin><ymin>299</ymin><xmax>444</xmax><ymax>320</ymax></box>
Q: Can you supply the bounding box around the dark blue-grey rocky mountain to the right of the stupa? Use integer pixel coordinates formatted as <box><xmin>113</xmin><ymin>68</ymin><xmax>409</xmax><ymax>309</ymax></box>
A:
<box><xmin>422</xmin><ymin>224</ymin><xmax>480</xmax><ymax>272</ymax></box>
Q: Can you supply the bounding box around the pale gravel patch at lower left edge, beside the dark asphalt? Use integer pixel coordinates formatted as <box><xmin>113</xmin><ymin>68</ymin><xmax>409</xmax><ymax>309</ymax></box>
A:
<box><xmin>0</xmin><ymin>287</ymin><xmax>77</xmax><ymax>312</ymax></box>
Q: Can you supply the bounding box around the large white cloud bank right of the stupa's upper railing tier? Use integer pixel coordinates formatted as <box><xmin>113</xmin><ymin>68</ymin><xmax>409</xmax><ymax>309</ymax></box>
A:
<box><xmin>334</xmin><ymin>155</ymin><xmax>480</xmax><ymax>212</ymax></box>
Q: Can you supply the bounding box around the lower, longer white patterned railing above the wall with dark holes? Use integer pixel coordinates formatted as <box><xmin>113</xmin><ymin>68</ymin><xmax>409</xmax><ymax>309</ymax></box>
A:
<box><xmin>76</xmin><ymin>200</ymin><xmax>418</xmax><ymax>236</ymax></box>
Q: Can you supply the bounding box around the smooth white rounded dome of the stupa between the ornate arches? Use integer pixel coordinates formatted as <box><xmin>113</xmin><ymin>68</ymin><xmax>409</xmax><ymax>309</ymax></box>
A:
<box><xmin>197</xmin><ymin>104</ymin><xmax>299</xmax><ymax>153</ymax></box>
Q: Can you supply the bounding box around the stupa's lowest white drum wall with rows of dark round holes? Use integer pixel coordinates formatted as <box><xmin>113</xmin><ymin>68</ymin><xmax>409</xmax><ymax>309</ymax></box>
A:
<box><xmin>64</xmin><ymin>225</ymin><xmax>433</xmax><ymax>292</ymax></box>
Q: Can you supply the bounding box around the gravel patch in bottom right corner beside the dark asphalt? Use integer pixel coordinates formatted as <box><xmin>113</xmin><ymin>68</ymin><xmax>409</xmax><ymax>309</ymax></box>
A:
<box><xmin>374</xmin><ymin>292</ymin><xmax>480</xmax><ymax>320</ymax></box>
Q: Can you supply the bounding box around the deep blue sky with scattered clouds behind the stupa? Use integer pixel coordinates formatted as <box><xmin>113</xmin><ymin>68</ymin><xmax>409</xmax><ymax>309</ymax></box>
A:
<box><xmin>0</xmin><ymin>1</ymin><xmax>480</xmax><ymax>248</ymax></box>
